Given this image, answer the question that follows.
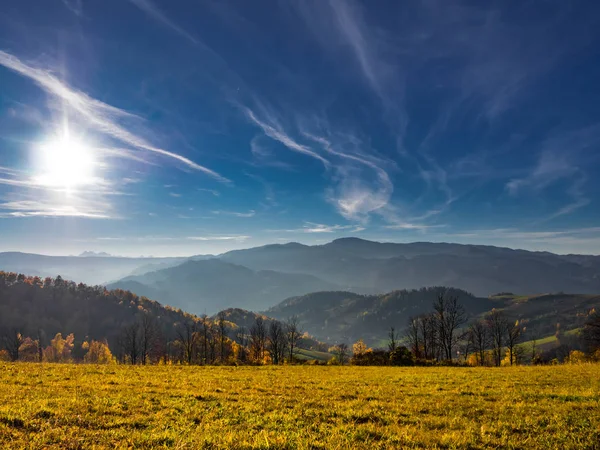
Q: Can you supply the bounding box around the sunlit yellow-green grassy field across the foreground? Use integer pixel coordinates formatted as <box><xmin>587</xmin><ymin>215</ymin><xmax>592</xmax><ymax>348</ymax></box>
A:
<box><xmin>0</xmin><ymin>363</ymin><xmax>600</xmax><ymax>449</ymax></box>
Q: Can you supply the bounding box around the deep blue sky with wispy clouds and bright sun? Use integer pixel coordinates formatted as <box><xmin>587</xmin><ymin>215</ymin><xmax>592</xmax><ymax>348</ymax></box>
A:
<box><xmin>0</xmin><ymin>0</ymin><xmax>600</xmax><ymax>256</ymax></box>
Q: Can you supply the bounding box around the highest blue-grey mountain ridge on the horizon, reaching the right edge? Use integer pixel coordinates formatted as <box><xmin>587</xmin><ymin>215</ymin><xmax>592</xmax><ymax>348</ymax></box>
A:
<box><xmin>220</xmin><ymin>238</ymin><xmax>600</xmax><ymax>296</ymax></box>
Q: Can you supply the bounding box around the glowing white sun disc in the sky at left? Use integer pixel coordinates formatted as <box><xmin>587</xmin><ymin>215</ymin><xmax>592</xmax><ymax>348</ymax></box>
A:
<box><xmin>38</xmin><ymin>133</ymin><xmax>96</xmax><ymax>189</ymax></box>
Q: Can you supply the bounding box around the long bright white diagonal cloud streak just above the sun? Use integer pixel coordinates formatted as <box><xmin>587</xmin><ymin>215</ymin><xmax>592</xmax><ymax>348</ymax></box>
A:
<box><xmin>0</xmin><ymin>50</ymin><xmax>230</xmax><ymax>182</ymax></box>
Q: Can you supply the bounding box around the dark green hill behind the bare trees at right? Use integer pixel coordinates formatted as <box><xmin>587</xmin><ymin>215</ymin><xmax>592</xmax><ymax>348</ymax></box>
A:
<box><xmin>265</xmin><ymin>287</ymin><xmax>600</xmax><ymax>345</ymax></box>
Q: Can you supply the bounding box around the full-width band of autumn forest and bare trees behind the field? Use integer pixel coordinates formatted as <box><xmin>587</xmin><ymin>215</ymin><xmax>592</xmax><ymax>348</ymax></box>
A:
<box><xmin>0</xmin><ymin>272</ymin><xmax>600</xmax><ymax>366</ymax></box>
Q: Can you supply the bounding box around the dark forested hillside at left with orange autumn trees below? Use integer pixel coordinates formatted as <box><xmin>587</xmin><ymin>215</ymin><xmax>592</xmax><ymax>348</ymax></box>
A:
<box><xmin>0</xmin><ymin>272</ymin><xmax>327</xmax><ymax>364</ymax></box>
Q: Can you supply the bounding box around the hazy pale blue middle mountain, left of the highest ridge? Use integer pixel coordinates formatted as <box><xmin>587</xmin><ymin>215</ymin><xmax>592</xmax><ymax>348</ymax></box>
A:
<box><xmin>108</xmin><ymin>259</ymin><xmax>337</xmax><ymax>314</ymax></box>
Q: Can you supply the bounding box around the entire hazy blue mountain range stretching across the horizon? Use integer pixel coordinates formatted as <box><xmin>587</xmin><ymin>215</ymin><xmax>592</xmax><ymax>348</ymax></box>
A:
<box><xmin>0</xmin><ymin>238</ymin><xmax>600</xmax><ymax>314</ymax></box>
